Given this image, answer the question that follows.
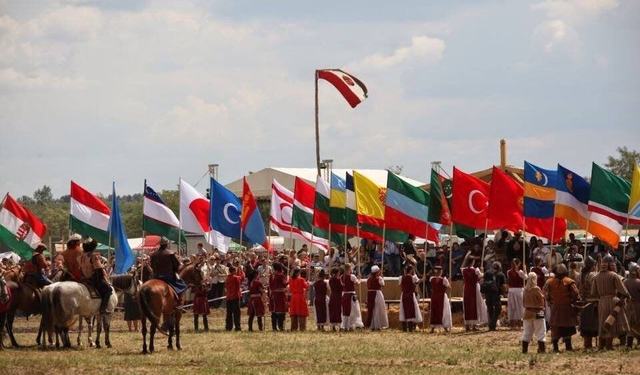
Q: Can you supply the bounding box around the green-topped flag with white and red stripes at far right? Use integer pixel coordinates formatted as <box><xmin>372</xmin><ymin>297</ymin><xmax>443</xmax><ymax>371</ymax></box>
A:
<box><xmin>588</xmin><ymin>163</ymin><xmax>640</xmax><ymax>224</ymax></box>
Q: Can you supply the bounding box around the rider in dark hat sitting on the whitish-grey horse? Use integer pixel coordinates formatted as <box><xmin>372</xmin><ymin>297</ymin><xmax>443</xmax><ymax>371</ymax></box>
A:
<box><xmin>79</xmin><ymin>237</ymin><xmax>113</xmax><ymax>315</ymax></box>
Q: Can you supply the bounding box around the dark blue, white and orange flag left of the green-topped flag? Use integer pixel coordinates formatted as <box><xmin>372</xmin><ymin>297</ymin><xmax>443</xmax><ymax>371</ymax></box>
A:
<box><xmin>556</xmin><ymin>164</ymin><xmax>622</xmax><ymax>248</ymax></box>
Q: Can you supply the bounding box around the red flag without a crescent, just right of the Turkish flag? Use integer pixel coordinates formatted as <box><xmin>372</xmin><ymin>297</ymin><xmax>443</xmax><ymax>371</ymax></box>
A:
<box><xmin>488</xmin><ymin>167</ymin><xmax>524</xmax><ymax>232</ymax></box>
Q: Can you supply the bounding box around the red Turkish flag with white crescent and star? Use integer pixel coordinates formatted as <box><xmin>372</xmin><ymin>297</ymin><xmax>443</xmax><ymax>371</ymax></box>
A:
<box><xmin>451</xmin><ymin>168</ymin><xmax>494</xmax><ymax>230</ymax></box>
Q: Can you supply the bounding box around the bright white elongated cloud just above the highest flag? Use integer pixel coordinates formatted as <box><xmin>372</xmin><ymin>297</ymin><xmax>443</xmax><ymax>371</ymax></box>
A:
<box><xmin>355</xmin><ymin>35</ymin><xmax>445</xmax><ymax>70</ymax></box>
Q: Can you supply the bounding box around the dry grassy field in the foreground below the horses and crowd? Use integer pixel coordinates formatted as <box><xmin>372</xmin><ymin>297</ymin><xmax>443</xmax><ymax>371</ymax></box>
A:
<box><xmin>0</xmin><ymin>311</ymin><xmax>640</xmax><ymax>375</ymax></box>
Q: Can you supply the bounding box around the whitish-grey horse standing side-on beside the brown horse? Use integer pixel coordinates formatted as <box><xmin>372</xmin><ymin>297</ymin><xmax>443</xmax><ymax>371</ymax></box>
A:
<box><xmin>42</xmin><ymin>275</ymin><xmax>140</xmax><ymax>348</ymax></box>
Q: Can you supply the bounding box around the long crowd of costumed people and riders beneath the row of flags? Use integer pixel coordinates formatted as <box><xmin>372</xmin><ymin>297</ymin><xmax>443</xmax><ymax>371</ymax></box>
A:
<box><xmin>2</xmin><ymin>231</ymin><xmax>640</xmax><ymax>353</ymax></box>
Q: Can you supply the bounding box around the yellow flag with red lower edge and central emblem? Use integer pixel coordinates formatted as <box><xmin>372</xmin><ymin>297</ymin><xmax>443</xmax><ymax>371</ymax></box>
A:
<box><xmin>353</xmin><ymin>171</ymin><xmax>387</xmax><ymax>227</ymax></box>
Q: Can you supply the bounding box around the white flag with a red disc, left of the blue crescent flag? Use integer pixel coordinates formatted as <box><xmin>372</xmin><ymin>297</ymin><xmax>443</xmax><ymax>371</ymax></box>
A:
<box><xmin>180</xmin><ymin>180</ymin><xmax>230</xmax><ymax>253</ymax></box>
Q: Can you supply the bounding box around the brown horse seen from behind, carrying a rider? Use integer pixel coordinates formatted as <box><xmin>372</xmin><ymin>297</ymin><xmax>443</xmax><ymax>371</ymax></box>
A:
<box><xmin>138</xmin><ymin>261</ymin><xmax>209</xmax><ymax>354</ymax></box>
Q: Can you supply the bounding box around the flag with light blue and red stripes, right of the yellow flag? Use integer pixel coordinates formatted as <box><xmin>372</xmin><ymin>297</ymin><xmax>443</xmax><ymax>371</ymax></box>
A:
<box><xmin>384</xmin><ymin>172</ymin><xmax>440</xmax><ymax>243</ymax></box>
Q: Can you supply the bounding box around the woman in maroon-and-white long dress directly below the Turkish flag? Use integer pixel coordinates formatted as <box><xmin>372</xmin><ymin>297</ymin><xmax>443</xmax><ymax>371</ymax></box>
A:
<box><xmin>462</xmin><ymin>253</ymin><xmax>489</xmax><ymax>331</ymax></box>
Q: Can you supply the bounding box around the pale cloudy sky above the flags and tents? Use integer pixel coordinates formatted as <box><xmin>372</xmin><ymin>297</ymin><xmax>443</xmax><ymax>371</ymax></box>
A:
<box><xmin>0</xmin><ymin>0</ymin><xmax>640</xmax><ymax>197</ymax></box>
